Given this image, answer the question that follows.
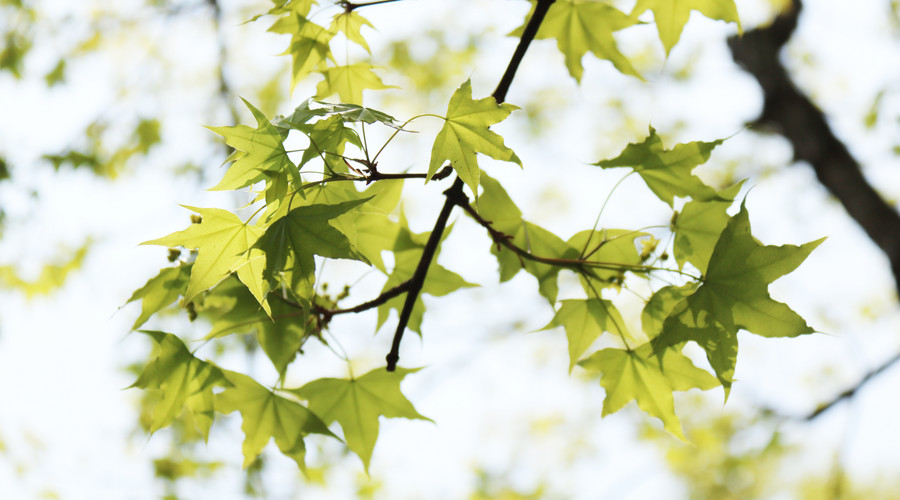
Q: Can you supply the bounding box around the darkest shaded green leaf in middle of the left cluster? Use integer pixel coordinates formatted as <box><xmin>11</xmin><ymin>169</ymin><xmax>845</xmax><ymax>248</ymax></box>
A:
<box><xmin>253</xmin><ymin>199</ymin><xmax>368</xmax><ymax>299</ymax></box>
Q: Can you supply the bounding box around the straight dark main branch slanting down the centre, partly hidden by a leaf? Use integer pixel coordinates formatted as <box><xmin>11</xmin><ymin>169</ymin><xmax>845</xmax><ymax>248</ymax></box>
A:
<box><xmin>385</xmin><ymin>0</ymin><xmax>554</xmax><ymax>372</ymax></box>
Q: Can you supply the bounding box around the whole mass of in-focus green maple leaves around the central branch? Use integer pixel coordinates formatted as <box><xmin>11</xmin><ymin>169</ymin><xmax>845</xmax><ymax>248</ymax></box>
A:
<box><xmin>130</xmin><ymin>0</ymin><xmax>819</xmax><ymax>476</ymax></box>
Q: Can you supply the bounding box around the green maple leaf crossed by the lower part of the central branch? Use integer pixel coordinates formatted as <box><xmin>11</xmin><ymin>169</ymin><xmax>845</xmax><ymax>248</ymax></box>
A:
<box><xmin>375</xmin><ymin>219</ymin><xmax>478</xmax><ymax>335</ymax></box>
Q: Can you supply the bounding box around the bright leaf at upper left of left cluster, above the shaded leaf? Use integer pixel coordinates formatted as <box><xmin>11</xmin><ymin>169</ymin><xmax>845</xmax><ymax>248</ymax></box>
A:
<box><xmin>207</xmin><ymin>99</ymin><xmax>299</xmax><ymax>191</ymax></box>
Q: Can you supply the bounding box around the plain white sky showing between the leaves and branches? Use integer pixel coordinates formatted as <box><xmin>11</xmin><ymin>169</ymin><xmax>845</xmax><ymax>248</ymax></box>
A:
<box><xmin>0</xmin><ymin>0</ymin><xmax>900</xmax><ymax>499</ymax></box>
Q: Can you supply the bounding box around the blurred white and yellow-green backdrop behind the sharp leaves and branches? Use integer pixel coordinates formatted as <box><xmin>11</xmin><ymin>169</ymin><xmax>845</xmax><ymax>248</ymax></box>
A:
<box><xmin>0</xmin><ymin>0</ymin><xmax>900</xmax><ymax>499</ymax></box>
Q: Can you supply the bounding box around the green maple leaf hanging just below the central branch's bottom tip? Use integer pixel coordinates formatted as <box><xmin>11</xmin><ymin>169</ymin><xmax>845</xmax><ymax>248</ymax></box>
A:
<box><xmin>289</xmin><ymin>368</ymin><xmax>431</xmax><ymax>473</ymax></box>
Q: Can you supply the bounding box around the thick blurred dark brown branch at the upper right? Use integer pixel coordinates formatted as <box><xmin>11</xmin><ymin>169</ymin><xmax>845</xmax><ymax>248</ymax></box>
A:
<box><xmin>728</xmin><ymin>0</ymin><xmax>900</xmax><ymax>290</ymax></box>
